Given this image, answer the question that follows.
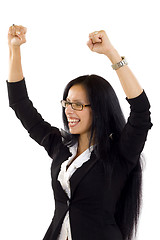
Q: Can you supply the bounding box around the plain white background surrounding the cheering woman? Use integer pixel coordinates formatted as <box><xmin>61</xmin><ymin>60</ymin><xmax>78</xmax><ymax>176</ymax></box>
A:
<box><xmin>0</xmin><ymin>0</ymin><xmax>160</xmax><ymax>240</ymax></box>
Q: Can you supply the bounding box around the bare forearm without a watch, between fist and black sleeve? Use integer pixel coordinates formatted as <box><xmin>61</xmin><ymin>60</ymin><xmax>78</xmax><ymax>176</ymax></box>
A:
<box><xmin>8</xmin><ymin>46</ymin><xmax>23</xmax><ymax>82</ymax></box>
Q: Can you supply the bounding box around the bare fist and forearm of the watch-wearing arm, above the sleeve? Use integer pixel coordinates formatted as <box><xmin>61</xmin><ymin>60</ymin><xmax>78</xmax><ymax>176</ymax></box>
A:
<box><xmin>87</xmin><ymin>30</ymin><xmax>143</xmax><ymax>99</ymax></box>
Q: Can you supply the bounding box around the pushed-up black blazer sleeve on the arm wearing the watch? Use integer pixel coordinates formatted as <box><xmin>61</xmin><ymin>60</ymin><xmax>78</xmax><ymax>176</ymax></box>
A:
<box><xmin>119</xmin><ymin>90</ymin><xmax>153</xmax><ymax>173</ymax></box>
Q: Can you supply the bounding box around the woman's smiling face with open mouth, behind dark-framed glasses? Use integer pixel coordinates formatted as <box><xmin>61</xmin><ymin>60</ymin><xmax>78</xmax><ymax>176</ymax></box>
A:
<box><xmin>65</xmin><ymin>84</ymin><xmax>92</xmax><ymax>137</ymax></box>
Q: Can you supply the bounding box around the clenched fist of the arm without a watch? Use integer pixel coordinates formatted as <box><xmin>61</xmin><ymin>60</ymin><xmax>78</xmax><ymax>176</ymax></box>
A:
<box><xmin>8</xmin><ymin>24</ymin><xmax>27</xmax><ymax>47</ymax></box>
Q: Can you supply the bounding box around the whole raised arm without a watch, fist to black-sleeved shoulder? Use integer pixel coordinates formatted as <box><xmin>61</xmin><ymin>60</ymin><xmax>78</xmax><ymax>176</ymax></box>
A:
<box><xmin>7</xmin><ymin>26</ymin><xmax>61</xmax><ymax>157</ymax></box>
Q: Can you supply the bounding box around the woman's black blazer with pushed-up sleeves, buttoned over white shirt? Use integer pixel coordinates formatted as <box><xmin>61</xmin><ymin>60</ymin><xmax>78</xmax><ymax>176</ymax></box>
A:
<box><xmin>7</xmin><ymin>79</ymin><xmax>152</xmax><ymax>240</ymax></box>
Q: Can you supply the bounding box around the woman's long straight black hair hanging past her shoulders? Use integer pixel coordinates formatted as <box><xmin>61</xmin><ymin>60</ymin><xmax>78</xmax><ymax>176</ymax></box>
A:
<box><xmin>62</xmin><ymin>74</ymin><xmax>142</xmax><ymax>240</ymax></box>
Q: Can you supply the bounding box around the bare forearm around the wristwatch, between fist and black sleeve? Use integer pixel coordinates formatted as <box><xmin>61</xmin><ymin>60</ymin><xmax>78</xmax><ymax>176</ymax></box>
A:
<box><xmin>105</xmin><ymin>49</ymin><xmax>143</xmax><ymax>99</ymax></box>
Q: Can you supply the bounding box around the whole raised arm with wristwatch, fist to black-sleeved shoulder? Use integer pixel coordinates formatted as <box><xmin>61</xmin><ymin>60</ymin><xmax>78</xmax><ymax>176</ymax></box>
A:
<box><xmin>87</xmin><ymin>31</ymin><xmax>152</xmax><ymax>172</ymax></box>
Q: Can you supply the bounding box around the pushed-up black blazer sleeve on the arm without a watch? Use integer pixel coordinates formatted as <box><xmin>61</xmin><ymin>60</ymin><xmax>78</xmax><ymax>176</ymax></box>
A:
<box><xmin>7</xmin><ymin>79</ymin><xmax>62</xmax><ymax>157</ymax></box>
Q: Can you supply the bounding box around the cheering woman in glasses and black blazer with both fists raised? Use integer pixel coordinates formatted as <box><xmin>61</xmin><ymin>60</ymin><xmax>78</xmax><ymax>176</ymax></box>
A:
<box><xmin>7</xmin><ymin>25</ymin><xmax>152</xmax><ymax>240</ymax></box>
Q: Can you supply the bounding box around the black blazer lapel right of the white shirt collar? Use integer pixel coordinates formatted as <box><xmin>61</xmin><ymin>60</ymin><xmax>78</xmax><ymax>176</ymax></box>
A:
<box><xmin>70</xmin><ymin>151</ymin><xmax>97</xmax><ymax>198</ymax></box>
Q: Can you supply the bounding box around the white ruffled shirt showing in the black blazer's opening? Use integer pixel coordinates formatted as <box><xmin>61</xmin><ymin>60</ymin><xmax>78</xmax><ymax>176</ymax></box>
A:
<box><xmin>57</xmin><ymin>144</ymin><xmax>93</xmax><ymax>240</ymax></box>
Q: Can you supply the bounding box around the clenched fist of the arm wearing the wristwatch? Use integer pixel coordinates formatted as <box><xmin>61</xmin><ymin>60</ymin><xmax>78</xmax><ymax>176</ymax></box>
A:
<box><xmin>87</xmin><ymin>30</ymin><xmax>114</xmax><ymax>55</ymax></box>
